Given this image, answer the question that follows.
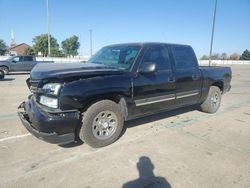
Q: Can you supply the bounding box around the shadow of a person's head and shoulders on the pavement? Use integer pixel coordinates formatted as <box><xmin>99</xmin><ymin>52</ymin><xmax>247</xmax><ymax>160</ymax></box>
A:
<box><xmin>122</xmin><ymin>156</ymin><xmax>171</xmax><ymax>188</ymax></box>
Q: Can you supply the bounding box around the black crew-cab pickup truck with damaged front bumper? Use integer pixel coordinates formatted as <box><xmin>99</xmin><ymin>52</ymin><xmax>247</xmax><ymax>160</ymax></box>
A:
<box><xmin>18</xmin><ymin>43</ymin><xmax>232</xmax><ymax>147</ymax></box>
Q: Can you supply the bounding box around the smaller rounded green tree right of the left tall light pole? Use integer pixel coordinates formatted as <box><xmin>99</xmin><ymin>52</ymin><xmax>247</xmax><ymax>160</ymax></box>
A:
<box><xmin>62</xmin><ymin>35</ymin><xmax>80</xmax><ymax>56</ymax></box>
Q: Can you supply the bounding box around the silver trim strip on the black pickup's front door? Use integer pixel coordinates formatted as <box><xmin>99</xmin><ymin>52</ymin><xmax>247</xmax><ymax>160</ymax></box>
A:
<box><xmin>135</xmin><ymin>94</ymin><xmax>175</xmax><ymax>106</ymax></box>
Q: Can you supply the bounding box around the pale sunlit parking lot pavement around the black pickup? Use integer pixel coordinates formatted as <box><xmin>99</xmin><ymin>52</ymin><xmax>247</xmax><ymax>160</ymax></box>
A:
<box><xmin>0</xmin><ymin>65</ymin><xmax>250</xmax><ymax>188</ymax></box>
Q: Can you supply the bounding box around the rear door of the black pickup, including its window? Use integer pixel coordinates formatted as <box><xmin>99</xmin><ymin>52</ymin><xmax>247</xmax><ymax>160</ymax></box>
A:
<box><xmin>171</xmin><ymin>45</ymin><xmax>202</xmax><ymax>106</ymax></box>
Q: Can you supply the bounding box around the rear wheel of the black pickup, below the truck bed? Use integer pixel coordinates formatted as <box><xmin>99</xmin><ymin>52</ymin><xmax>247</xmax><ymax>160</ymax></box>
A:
<box><xmin>201</xmin><ymin>86</ymin><xmax>221</xmax><ymax>113</ymax></box>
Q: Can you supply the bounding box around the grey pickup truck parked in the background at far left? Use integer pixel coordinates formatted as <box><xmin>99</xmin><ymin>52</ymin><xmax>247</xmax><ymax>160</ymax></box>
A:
<box><xmin>0</xmin><ymin>55</ymin><xmax>53</xmax><ymax>74</ymax></box>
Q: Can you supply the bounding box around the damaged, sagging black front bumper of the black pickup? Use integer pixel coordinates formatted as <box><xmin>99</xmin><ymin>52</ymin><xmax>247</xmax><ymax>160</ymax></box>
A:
<box><xmin>18</xmin><ymin>97</ymin><xmax>79</xmax><ymax>145</ymax></box>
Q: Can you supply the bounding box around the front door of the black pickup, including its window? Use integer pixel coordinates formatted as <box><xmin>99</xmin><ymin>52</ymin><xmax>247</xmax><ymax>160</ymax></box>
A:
<box><xmin>133</xmin><ymin>45</ymin><xmax>175</xmax><ymax>116</ymax></box>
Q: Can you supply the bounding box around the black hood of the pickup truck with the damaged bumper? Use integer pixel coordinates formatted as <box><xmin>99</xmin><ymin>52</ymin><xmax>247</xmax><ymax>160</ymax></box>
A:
<box><xmin>30</xmin><ymin>63</ymin><xmax>123</xmax><ymax>80</ymax></box>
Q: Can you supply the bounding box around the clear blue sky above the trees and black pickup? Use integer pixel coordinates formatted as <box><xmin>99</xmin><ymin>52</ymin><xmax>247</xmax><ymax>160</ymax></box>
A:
<box><xmin>0</xmin><ymin>0</ymin><xmax>250</xmax><ymax>57</ymax></box>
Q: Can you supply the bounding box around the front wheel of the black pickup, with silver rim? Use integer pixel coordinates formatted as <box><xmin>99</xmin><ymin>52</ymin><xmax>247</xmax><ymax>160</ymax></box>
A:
<box><xmin>79</xmin><ymin>100</ymin><xmax>124</xmax><ymax>148</ymax></box>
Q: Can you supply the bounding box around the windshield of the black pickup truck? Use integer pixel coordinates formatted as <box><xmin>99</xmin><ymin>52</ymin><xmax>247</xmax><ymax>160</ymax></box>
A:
<box><xmin>88</xmin><ymin>45</ymin><xmax>141</xmax><ymax>70</ymax></box>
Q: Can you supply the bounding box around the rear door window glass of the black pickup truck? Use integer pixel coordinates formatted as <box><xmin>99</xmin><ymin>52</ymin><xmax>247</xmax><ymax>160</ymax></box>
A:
<box><xmin>172</xmin><ymin>46</ymin><xmax>197</xmax><ymax>69</ymax></box>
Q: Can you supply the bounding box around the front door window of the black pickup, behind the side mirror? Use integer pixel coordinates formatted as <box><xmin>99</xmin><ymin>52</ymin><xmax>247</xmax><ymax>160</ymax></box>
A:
<box><xmin>140</xmin><ymin>46</ymin><xmax>171</xmax><ymax>71</ymax></box>
